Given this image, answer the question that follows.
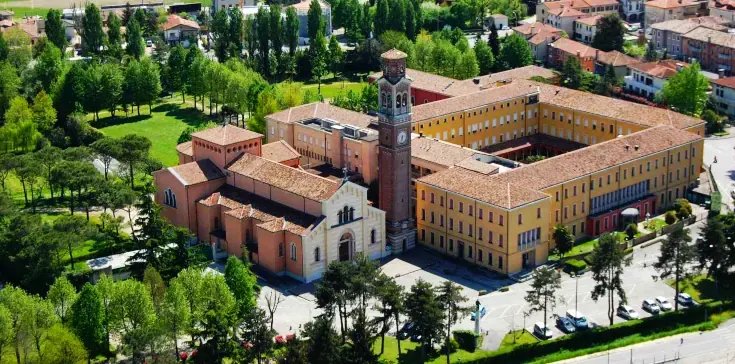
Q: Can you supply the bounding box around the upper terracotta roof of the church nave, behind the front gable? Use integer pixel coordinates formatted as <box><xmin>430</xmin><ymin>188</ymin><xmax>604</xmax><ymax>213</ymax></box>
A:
<box><xmin>227</xmin><ymin>153</ymin><xmax>339</xmax><ymax>201</ymax></box>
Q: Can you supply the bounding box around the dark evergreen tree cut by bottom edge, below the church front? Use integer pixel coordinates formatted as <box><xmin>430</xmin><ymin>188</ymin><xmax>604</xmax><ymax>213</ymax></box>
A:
<box><xmin>304</xmin><ymin>314</ymin><xmax>341</xmax><ymax>363</ymax></box>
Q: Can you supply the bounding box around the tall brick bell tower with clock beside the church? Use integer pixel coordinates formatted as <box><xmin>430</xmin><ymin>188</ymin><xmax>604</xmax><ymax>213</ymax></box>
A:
<box><xmin>377</xmin><ymin>49</ymin><xmax>416</xmax><ymax>253</ymax></box>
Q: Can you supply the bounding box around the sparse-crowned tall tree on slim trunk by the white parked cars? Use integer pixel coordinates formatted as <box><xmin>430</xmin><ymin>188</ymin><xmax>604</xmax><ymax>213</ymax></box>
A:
<box><xmin>653</xmin><ymin>227</ymin><xmax>697</xmax><ymax>311</ymax></box>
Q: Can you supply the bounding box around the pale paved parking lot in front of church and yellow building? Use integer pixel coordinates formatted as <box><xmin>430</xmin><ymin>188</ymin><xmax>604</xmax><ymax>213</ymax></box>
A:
<box><xmin>254</xmin><ymin>222</ymin><xmax>702</xmax><ymax>350</ymax></box>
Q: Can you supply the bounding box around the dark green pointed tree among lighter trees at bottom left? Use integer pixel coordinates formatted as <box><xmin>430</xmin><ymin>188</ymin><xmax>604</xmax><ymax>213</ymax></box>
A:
<box><xmin>69</xmin><ymin>283</ymin><xmax>106</xmax><ymax>359</ymax></box>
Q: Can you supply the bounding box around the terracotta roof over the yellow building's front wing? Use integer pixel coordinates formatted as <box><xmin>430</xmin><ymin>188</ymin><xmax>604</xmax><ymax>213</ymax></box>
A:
<box><xmin>419</xmin><ymin>126</ymin><xmax>702</xmax><ymax>209</ymax></box>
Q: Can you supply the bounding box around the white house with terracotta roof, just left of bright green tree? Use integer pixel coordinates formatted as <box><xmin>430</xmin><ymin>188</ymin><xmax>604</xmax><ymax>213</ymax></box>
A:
<box><xmin>625</xmin><ymin>59</ymin><xmax>689</xmax><ymax>100</ymax></box>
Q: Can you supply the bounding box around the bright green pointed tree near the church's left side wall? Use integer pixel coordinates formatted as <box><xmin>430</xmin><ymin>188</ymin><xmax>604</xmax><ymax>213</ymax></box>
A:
<box><xmin>225</xmin><ymin>255</ymin><xmax>258</xmax><ymax>318</ymax></box>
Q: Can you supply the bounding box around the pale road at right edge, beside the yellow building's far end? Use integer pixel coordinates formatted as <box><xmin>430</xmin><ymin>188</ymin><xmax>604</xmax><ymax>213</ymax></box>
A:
<box><xmin>704</xmin><ymin>136</ymin><xmax>735</xmax><ymax>211</ymax></box>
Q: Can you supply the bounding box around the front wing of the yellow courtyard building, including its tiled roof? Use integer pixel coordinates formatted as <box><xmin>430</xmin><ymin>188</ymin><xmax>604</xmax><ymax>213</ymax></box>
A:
<box><xmin>416</xmin><ymin>125</ymin><xmax>704</xmax><ymax>274</ymax></box>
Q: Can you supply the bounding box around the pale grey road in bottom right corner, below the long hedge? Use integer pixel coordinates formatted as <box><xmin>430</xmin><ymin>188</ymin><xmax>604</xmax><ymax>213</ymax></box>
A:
<box><xmin>559</xmin><ymin>320</ymin><xmax>735</xmax><ymax>364</ymax></box>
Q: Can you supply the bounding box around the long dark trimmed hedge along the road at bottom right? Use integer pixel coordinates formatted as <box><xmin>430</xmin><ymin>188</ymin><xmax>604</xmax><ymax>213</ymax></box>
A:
<box><xmin>467</xmin><ymin>303</ymin><xmax>735</xmax><ymax>364</ymax></box>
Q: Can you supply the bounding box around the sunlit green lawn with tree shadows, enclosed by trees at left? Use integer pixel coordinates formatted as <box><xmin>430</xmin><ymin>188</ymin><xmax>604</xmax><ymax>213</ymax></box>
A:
<box><xmin>92</xmin><ymin>101</ymin><xmax>209</xmax><ymax>166</ymax></box>
